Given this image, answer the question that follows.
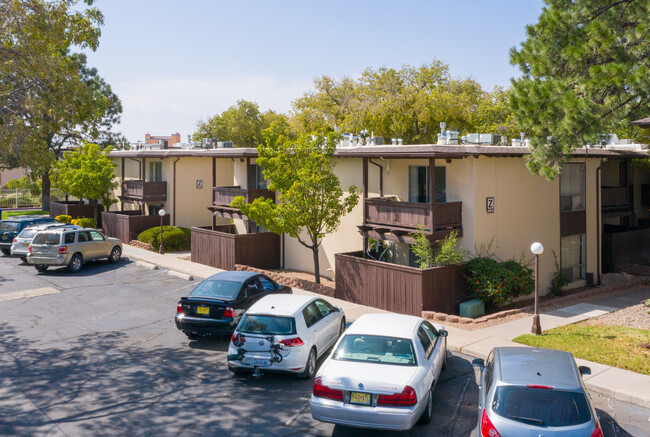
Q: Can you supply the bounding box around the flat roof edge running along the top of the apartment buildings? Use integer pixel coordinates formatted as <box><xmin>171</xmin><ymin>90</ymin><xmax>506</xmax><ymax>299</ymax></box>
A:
<box><xmin>109</xmin><ymin>144</ymin><xmax>648</xmax><ymax>159</ymax></box>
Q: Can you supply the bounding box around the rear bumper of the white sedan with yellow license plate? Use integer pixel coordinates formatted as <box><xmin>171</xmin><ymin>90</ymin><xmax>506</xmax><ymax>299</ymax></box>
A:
<box><xmin>310</xmin><ymin>396</ymin><xmax>421</xmax><ymax>431</ymax></box>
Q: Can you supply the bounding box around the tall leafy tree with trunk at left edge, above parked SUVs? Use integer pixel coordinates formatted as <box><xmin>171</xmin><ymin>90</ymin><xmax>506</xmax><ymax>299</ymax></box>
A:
<box><xmin>0</xmin><ymin>0</ymin><xmax>122</xmax><ymax>209</ymax></box>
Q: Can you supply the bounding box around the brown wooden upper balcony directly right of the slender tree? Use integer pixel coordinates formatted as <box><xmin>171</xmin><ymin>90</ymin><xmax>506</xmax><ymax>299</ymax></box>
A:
<box><xmin>360</xmin><ymin>198</ymin><xmax>463</xmax><ymax>243</ymax></box>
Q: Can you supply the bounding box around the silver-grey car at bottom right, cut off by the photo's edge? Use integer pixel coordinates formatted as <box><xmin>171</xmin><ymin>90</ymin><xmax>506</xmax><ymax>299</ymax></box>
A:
<box><xmin>472</xmin><ymin>347</ymin><xmax>603</xmax><ymax>437</ymax></box>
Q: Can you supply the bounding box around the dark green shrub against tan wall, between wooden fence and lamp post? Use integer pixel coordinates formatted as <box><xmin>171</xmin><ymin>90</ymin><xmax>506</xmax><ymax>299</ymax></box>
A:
<box><xmin>463</xmin><ymin>257</ymin><xmax>535</xmax><ymax>308</ymax></box>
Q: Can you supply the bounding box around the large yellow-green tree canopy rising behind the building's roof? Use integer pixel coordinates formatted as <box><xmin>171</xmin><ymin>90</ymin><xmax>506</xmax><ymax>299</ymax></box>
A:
<box><xmin>292</xmin><ymin>60</ymin><xmax>519</xmax><ymax>144</ymax></box>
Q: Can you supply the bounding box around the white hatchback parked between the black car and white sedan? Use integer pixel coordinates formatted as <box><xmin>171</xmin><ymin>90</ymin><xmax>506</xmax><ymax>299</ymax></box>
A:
<box><xmin>227</xmin><ymin>294</ymin><xmax>345</xmax><ymax>378</ymax></box>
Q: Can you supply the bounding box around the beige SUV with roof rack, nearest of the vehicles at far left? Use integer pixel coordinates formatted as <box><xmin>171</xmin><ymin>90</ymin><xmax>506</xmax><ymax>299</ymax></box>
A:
<box><xmin>27</xmin><ymin>228</ymin><xmax>122</xmax><ymax>272</ymax></box>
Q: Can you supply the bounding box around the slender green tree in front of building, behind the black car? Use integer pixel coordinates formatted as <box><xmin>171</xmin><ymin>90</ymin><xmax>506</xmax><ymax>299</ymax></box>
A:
<box><xmin>232</xmin><ymin>129</ymin><xmax>359</xmax><ymax>283</ymax></box>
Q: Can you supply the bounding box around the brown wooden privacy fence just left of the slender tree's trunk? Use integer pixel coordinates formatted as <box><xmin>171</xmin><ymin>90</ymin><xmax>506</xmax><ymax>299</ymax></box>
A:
<box><xmin>191</xmin><ymin>225</ymin><xmax>280</xmax><ymax>270</ymax></box>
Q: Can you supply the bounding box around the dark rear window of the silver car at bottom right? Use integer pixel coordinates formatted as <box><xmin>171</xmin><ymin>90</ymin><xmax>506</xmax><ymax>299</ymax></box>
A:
<box><xmin>492</xmin><ymin>386</ymin><xmax>591</xmax><ymax>427</ymax></box>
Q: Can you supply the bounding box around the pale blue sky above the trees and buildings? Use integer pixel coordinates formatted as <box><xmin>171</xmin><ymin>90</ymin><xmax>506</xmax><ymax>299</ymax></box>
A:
<box><xmin>83</xmin><ymin>0</ymin><xmax>542</xmax><ymax>142</ymax></box>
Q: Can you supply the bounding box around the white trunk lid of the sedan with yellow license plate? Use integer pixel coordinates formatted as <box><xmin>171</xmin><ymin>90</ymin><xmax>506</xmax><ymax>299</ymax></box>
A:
<box><xmin>320</xmin><ymin>359</ymin><xmax>418</xmax><ymax>393</ymax></box>
